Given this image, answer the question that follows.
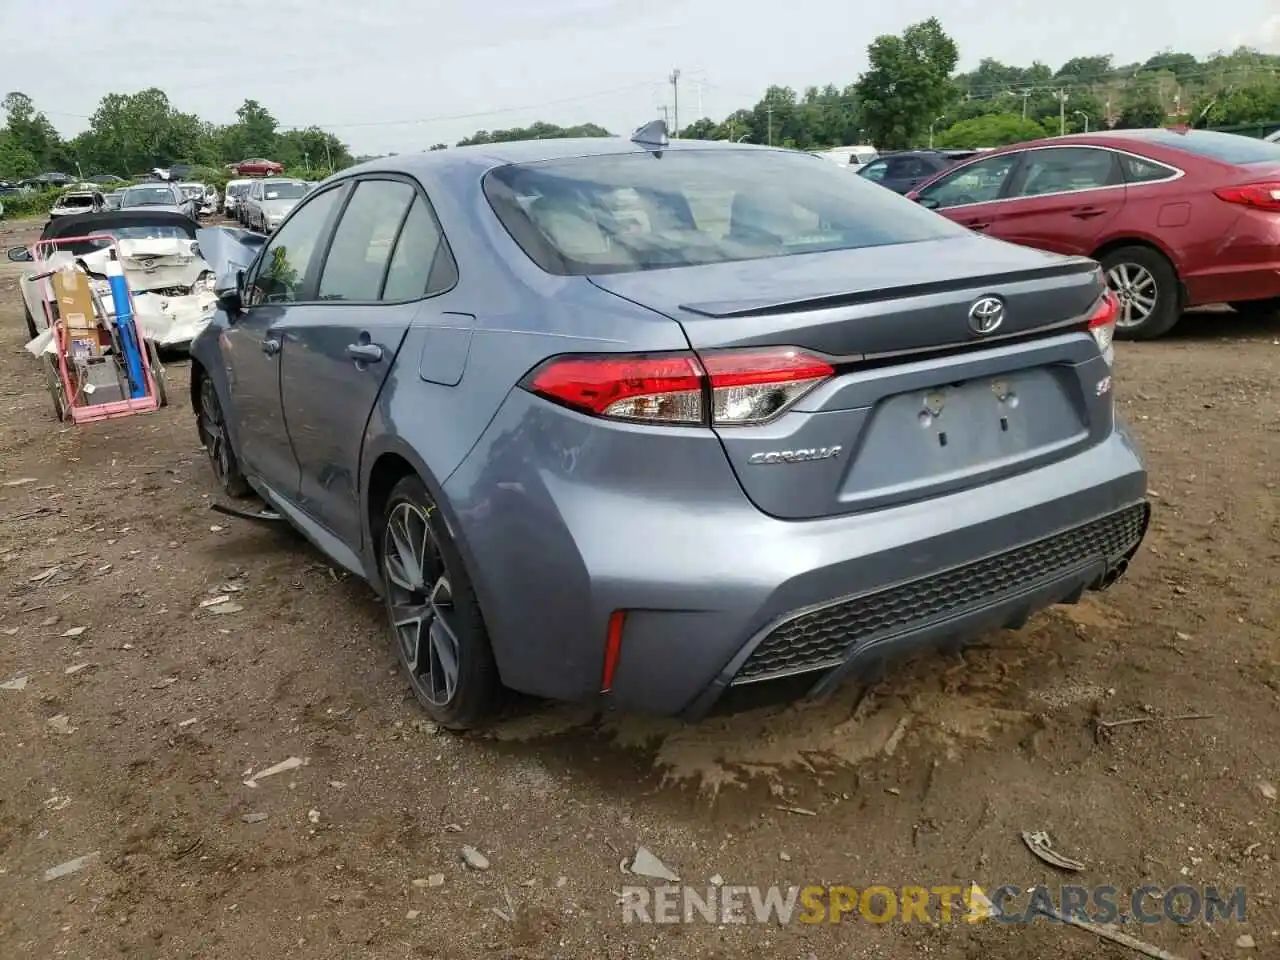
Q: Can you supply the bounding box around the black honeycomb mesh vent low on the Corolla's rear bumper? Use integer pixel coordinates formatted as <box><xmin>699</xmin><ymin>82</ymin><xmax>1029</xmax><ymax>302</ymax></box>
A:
<box><xmin>732</xmin><ymin>503</ymin><xmax>1149</xmax><ymax>684</ymax></box>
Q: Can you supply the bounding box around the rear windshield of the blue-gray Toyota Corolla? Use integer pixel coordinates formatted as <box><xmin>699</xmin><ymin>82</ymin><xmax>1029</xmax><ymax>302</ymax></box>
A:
<box><xmin>484</xmin><ymin>148</ymin><xmax>966</xmax><ymax>275</ymax></box>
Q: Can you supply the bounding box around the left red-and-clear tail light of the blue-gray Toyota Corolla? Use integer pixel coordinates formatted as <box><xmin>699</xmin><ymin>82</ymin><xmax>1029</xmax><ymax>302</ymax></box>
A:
<box><xmin>521</xmin><ymin>347</ymin><xmax>835</xmax><ymax>426</ymax></box>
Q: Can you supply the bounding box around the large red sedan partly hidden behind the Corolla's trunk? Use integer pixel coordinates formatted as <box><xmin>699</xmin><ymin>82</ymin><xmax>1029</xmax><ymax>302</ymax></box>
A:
<box><xmin>908</xmin><ymin>128</ymin><xmax>1280</xmax><ymax>339</ymax></box>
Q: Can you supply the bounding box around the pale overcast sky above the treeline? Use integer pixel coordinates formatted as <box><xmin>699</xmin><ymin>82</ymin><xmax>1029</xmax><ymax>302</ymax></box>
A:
<box><xmin>0</xmin><ymin>0</ymin><xmax>1280</xmax><ymax>152</ymax></box>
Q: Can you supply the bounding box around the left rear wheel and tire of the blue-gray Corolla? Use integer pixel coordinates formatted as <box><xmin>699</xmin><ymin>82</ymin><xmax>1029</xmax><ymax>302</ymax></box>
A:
<box><xmin>378</xmin><ymin>475</ymin><xmax>503</xmax><ymax>731</ymax></box>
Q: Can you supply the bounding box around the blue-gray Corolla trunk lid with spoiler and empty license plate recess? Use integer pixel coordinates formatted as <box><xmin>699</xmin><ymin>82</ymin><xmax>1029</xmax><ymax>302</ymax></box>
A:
<box><xmin>591</xmin><ymin>237</ymin><xmax>1112</xmax><ymax>520</ymax></box>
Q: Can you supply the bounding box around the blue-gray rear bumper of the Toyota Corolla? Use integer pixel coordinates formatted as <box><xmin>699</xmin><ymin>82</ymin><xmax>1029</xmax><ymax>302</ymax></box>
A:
<box><xmin>444</xmin><ymin>390</ymin><xmax>1147</xmax><ymax>716</ymax></box>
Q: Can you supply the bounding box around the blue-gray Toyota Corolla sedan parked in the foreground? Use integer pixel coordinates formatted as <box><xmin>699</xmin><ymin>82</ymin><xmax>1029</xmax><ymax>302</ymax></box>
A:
<box><xmin>191</xmin><ymin>124</ymin><xmax>1149</xmax><ymax>728</ymax></box>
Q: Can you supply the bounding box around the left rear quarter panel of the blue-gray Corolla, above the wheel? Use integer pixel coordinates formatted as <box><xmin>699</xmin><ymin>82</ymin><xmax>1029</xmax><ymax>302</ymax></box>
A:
<box><xmin>361</xmin><ymin>160</ymin><xmax>689</xmax><ymax>586</ymax></box>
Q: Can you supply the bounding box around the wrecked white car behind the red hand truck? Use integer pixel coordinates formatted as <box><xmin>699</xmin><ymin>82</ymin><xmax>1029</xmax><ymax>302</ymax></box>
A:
<box><xmin>9</xmin><ymin>210</ymin><xmax>262</xmax><ymax>355</ymax></box>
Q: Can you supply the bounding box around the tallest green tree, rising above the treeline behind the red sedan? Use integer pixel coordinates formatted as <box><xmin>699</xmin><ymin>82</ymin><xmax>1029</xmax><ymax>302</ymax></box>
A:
<box><xmin>856</xmin><ymin>17</ymin><xmax>959</xmax><ymax>150</ymax></box>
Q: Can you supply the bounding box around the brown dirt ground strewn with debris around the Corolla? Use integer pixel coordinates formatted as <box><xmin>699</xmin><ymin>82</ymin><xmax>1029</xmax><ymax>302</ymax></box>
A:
<box><xmin>0</xmin><ymin>223</ymin><xmax>1280</xmax><ymax>960</ymax></box>
